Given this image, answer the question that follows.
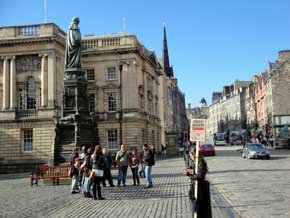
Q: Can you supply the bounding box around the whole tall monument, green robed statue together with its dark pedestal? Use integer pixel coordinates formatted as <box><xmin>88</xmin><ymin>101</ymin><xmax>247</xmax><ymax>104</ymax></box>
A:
<box><xmin>55</xmin><ymin>17</ymin><xmax>98</xmax><ymax>163</ymax></box>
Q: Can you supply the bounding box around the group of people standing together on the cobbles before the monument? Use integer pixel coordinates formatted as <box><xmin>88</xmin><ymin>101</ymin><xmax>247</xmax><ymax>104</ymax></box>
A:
<box><xmin>69</xmin><ymin>144</ymin><xmax>155</xmax><ymax>200</ymax></box>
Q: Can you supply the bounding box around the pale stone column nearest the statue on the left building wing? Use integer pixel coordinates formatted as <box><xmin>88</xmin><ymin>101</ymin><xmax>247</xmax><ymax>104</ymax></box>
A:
<box><xmin>47</xmin><ymin>54</ymin><xmax>56</xmax><ymax>108</ymax></box>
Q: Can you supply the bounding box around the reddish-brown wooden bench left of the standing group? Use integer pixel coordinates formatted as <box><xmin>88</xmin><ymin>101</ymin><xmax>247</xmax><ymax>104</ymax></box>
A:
<box><xmin>30</xmin><ymin>166</ymin><xmax>71</xmax><ymax>186</ymax></box>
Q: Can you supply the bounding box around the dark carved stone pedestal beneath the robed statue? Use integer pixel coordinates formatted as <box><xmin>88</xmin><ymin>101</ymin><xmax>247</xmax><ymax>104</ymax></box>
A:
<box><xmin>55</xmin><ymin>69</ymin><xmax>99</xmax><ymax>163</ymax></box>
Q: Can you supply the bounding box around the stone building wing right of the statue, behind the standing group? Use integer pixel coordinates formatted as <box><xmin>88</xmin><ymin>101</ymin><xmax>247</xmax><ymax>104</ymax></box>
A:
<box><xmin>82</xmin><ymin>34</ymin><xmax>162</xmax><ymax>152</ymax></box>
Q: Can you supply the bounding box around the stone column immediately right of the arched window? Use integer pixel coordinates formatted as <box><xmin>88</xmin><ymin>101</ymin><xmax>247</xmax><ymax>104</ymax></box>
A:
<box><xmin>41</xmin><ymin>54</ymin><xmax>48</xmax><ymax>107</ymax></box>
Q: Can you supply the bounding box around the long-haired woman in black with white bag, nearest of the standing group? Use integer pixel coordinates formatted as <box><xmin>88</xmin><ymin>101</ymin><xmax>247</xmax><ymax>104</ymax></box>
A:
<box><xmin>91</xmin><ymin>145</ymin><xmax>105</xmax><ymax>200</ymax></box>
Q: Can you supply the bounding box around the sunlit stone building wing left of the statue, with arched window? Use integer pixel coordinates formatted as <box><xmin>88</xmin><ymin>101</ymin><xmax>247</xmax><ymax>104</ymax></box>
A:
<box><xmin>0</xmin><ymin>24</ymin><xmax>66</xmax><ymax>167</ymax></box>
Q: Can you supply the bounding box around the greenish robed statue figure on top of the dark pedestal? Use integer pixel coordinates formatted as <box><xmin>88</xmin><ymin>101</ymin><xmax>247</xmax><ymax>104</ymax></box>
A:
<box><xmin>65</xmin><ymin>17</ymin><xmax>81</xmax><ymax>69</ymax></box>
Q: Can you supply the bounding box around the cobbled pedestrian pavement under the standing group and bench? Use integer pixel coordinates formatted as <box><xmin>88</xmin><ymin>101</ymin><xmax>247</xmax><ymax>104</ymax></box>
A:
<box><xmin>0</xmin><ymin>158</ymin><xmax>238</xmax><ymax>218</ymax></box>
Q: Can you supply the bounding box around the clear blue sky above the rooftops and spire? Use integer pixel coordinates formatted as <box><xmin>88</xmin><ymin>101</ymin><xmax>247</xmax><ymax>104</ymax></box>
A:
<box><xmin>0</xmin><ymin>0</ymin><xmax>290</xmax><ymax>105</ymax></box>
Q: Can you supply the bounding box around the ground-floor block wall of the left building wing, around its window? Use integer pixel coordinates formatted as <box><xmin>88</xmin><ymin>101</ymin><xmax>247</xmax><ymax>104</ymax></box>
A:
<box><xmin>0</xmin><ymin>121</ymin><xmax>55</xmax><ymax>164</ymax></box>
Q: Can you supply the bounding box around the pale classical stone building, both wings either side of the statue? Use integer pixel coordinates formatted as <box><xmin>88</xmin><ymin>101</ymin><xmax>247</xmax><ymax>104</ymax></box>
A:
<box><xmin>0</xmin><ymin>23</ymin><xmax>163</xmax><ymax>169</ymax></box>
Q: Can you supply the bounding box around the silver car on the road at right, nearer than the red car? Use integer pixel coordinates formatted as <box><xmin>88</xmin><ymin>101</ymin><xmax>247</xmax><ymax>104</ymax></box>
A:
<box><xmin>242</xmin><ymin>143</ymin><xmax>270</xmax><ymax>160</ymax></box>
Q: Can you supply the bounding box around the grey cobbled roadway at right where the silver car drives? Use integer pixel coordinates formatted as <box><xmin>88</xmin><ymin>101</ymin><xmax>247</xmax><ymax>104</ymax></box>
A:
<box><xmin>207</xmin><ymin>146</ymin><xmax>290</xmax><ymax>218</ymax></box>
